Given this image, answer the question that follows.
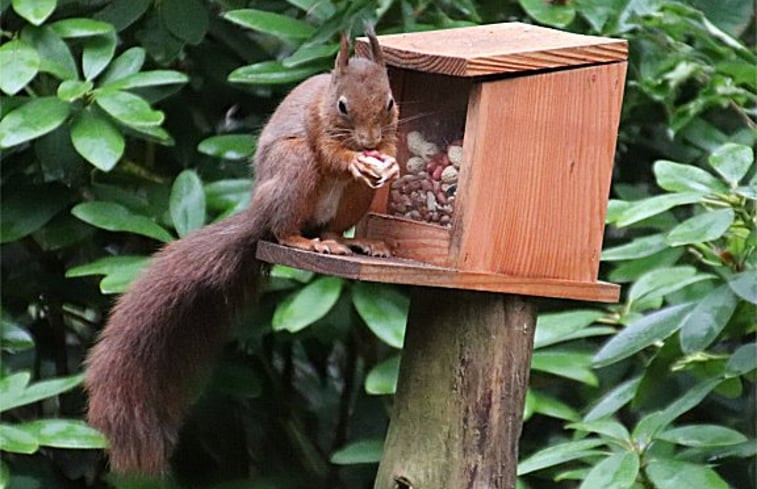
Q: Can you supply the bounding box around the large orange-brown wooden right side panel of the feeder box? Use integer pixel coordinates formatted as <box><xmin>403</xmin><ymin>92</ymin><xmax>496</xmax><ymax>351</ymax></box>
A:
<box><xmin>450</xmin><ymin>62</ymin><xmax>626</xmax><ymax>283</ymax></box>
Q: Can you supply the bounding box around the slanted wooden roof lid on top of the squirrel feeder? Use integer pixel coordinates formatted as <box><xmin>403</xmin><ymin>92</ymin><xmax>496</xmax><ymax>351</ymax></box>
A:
<box><xmin>355</xmin><ymin>22</ymin><xmax>628</xmax><ymax>77</ymax></box>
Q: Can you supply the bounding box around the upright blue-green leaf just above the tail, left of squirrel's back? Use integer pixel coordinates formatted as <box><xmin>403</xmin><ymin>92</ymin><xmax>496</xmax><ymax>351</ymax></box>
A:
<box><xmin>169</xmin><ymin>170</ymin><xmax>205</xmax><ymax>237</ymax></box>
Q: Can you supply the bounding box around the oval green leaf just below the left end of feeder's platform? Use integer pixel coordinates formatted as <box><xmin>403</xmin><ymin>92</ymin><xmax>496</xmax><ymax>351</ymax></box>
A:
<box><xmin>273</xmin><ymin>277</ymin><xmax>344</xmax><ymax>333</ymax></box>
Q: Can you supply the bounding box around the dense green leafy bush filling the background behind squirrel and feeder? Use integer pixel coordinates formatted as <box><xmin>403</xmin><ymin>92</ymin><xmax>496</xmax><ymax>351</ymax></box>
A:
<box><xmin>0</xmin><ymin>0</ymin><xmax>757</xmax><ymax>489</ymax></box>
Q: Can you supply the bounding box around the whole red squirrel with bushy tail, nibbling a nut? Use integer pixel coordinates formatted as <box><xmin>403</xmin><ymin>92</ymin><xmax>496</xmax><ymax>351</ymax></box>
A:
<box><xmin>85</xmin><ymin>28</ymin><xmax>399</xmax><ymax>476</ymax></box>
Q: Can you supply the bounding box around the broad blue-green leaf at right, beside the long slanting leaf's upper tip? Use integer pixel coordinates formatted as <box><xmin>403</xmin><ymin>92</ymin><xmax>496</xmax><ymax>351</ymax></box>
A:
<box><xmin>681</xmin><ymin>285</ymin><xmax>738</xmax><ymax>353</ymax></box>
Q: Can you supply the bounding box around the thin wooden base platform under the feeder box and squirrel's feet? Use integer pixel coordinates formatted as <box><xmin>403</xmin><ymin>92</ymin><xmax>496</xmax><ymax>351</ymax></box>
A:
<box><xmin>257</xmin><ymin>241</ymin><xmax>620</xmax><ymax>302</ymax></box>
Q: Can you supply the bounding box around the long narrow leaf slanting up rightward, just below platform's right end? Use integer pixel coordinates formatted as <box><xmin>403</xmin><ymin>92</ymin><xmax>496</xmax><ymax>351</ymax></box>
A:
<box><xmin>594</xmin><ymin>304</ymin><xmax>693</xmax><ymax>367</ymax></box>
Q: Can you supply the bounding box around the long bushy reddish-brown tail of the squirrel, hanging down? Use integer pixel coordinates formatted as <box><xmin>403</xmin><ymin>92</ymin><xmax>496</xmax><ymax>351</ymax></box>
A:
<box><xmin>85</xmin><ymin>210</ymin><xmax>267</xmax><ymax>475</ymax></box>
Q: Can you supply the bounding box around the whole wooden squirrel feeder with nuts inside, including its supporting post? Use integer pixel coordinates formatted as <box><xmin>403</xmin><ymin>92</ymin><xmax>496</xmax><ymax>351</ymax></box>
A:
<box><xmin>258</xmin><ymin>23</ymin><xmax>627</xmax><ymax>489</ymax></box>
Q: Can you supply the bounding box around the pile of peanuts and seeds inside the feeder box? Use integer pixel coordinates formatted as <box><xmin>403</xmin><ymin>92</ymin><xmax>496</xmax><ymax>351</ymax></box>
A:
<box><xmin>389</xmin><ymin>131</ymin><xmax>463</xmax><ymax>227</ymax></box>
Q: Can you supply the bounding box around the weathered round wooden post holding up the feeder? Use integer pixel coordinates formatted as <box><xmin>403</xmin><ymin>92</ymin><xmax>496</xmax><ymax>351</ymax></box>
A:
<box><xmin>374</xmin><ymin>288</ymin><xmax>536</xmax><ymax>489</ymax></box>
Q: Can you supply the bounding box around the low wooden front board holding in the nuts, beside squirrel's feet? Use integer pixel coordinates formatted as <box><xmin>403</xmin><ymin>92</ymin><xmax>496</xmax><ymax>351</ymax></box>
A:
<box><xmin>364</xmin><ymin>214</ymin><xmax>450</xmax><ymax>267</ymax></box>
